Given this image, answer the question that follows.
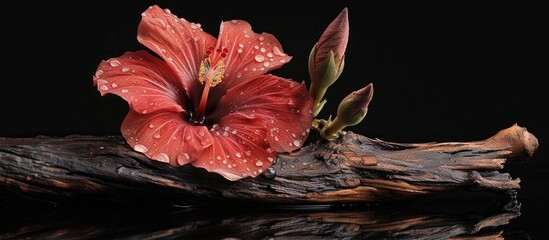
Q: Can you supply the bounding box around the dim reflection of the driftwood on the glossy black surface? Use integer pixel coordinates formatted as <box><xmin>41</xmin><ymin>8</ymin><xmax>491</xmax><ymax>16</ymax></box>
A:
<box><xmin>0</xmin><ymin>192</ymin><xmax>528</xmax><ymax>239</ymax></box>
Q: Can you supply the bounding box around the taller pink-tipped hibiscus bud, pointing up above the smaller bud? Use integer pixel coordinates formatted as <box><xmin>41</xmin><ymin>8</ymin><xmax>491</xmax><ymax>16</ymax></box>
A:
<box><xmin>309</xmin><ymin>8</ymin><xmax>349</xmax><ymax>116</ymax></box>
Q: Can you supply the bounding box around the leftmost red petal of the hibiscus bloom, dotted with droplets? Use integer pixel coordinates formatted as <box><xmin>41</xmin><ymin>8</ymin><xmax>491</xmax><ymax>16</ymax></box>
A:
<box><xmin>93</xmin><ymin>51</ymin><xmax>188</xmax><ymax>113</ymax></box>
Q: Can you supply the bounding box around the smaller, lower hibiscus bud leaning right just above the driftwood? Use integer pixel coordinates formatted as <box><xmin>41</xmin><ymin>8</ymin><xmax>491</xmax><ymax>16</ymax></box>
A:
<box><xmin>321</xmin><ymin>83</ymin><xmax>374</xmax><ymax>139</ymax></box>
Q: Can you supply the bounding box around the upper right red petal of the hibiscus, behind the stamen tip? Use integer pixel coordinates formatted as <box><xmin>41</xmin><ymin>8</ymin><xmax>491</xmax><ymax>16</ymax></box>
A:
<box><xmin>214</xmin><ymin>20</ymin><xmax>292</xmax><ymax>89</ymax></box>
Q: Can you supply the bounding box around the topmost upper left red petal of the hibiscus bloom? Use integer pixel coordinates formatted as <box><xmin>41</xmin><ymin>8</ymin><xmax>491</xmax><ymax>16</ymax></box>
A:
<box><xmin>137</xmin><ymin>5</ymin><xmax>215</xmax><ymax>99</ymax></box>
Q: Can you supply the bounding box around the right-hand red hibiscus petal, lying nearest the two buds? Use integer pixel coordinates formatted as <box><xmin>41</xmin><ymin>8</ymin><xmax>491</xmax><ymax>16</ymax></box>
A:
<box><xmin>210</xmin><ymin>75</ymin><xmax>313</xmax><ymax>152</ymax></box>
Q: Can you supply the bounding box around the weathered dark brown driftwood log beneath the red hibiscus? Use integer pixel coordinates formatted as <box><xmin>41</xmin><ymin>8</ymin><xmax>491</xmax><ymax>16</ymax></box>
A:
<box><xmin>0</xmin><ymin>125</ymin><xmax>538</xmax><ymax>204</ymax></box>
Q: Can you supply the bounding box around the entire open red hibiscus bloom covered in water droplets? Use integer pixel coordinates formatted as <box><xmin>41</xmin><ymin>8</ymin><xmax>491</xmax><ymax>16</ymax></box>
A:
<box><xmin>93</xmin><ymin>6</ymin><xmax>313</xmax><ymax>180</ymax></box>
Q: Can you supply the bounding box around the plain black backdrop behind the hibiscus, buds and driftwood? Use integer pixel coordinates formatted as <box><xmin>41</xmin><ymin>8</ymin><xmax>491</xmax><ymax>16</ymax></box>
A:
<box><xmin>0</xmin><ymin>1</ymin><xmax>549</xmax><ymax>239</ymax></box>
